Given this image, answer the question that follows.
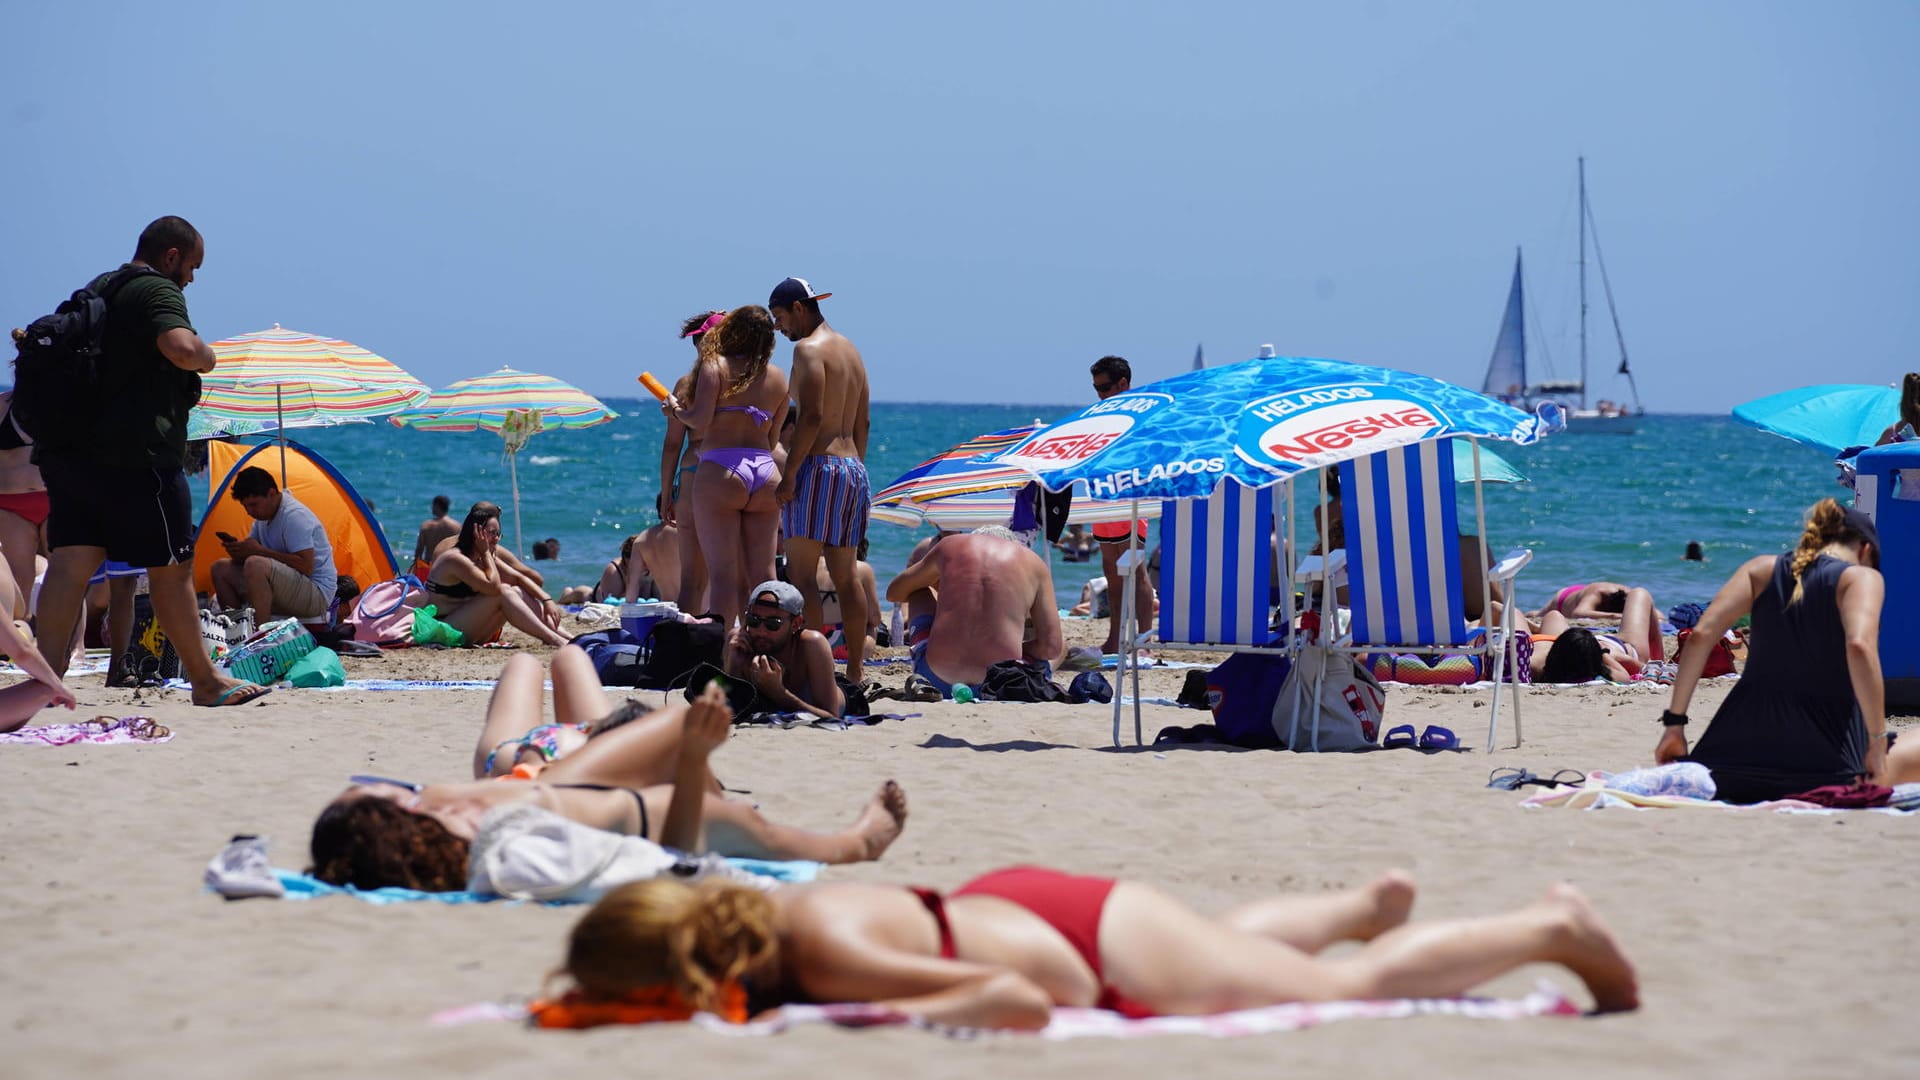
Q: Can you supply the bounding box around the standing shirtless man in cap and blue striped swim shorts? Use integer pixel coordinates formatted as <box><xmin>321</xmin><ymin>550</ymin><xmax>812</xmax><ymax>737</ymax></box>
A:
<box><xmin>766</xmin><ymin>277</ymin><xmax>872</xmax><ymax>684</ymax></box>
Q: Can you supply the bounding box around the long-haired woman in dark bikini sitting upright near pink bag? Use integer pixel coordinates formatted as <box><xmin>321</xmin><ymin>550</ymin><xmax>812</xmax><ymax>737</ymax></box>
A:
<box><xmin>422</xmin><ymin>502</ymin><xmax>566</xmax><ymax>646</ymax></box>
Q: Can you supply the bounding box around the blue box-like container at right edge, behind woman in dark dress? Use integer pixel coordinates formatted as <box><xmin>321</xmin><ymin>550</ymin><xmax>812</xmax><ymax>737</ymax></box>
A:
<box><xmin>1853</xmin><ymin>442</ymin><xmax>1920</xmax><ymax>707</ymax></box>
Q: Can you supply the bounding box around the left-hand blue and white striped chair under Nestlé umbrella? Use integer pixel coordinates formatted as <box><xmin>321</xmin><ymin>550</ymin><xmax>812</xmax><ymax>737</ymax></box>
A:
<box><xmin>1108</xmin><ymin>480</ymin><xmax>1283</xmax><ymax>746</ymax></box>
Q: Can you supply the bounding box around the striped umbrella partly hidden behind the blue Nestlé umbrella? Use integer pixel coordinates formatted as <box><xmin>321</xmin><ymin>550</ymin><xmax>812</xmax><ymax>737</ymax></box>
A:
<box><xmin>872</xmin><ymin>421</ymin><xmax>1160</xmax><ymax>528</ymax></box>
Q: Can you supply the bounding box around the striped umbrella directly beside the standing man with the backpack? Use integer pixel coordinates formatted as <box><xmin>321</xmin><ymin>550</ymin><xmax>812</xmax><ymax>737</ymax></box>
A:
<box><xmin>186</xmin><ymin>323</ymin><xmax>432</xmax><ymax>480</ymax></box>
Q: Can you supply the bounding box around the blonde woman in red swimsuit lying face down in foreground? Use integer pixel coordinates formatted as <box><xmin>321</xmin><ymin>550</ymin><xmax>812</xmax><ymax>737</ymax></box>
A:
<box><xmin>563</xmin><ymin>867</ymin><xmax>1640</xmax><ymax>1028</ymax></box>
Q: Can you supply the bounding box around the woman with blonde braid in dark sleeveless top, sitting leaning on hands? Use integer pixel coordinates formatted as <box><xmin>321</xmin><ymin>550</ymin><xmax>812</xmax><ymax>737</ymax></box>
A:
<box><xmin>1653</xmin><ymin>500</ymin><xmax>1920</xmax><ymax>803</ymax></box>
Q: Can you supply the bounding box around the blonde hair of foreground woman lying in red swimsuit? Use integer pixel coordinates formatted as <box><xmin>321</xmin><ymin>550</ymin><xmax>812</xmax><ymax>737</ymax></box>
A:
<box><xmin>555</xmin><ymin>878</ymin><xmax>780</xmax><ymax>1011</ymax></box>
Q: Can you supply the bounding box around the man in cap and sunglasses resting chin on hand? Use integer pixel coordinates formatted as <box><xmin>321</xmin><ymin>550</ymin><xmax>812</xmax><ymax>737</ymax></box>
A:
<box><xmin>726</xmin><ymin>580</ymin><xmax>847</xmax><ymax>721</ymax></box>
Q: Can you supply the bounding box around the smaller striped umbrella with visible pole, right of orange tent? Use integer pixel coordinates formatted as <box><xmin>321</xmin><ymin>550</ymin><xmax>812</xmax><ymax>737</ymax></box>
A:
<box><xmin>388</xmin><ymin>367</ymin><xmax>620</xmax><ymax>552</ymax></box>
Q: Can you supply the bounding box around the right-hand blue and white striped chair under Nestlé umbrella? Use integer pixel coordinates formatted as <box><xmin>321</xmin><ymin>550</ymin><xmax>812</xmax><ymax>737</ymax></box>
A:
<box><xmin>1332</xmin><ymin>438</ymin><xmax>1534</xmax><ymax>749</ymax></box>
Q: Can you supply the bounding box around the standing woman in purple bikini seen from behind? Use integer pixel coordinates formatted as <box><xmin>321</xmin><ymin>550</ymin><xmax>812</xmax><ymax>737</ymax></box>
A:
<box><xmin>660</xmin><ymin>304</ymin><xmax>787</xmax><ymax>626</ymax></box>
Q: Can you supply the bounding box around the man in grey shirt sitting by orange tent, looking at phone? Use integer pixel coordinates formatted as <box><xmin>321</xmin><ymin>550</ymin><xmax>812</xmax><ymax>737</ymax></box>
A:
<box><xmin>211</xmin><ymin>465</ymin><xmax>338</xmax><ymax>626</ymax></box>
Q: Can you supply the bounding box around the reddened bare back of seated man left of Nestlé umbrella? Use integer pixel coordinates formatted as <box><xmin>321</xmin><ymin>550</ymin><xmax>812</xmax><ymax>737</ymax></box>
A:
<box><xmin>927</xmin><ymin>534</ymin><xmax>1043</xmax><ymax>682</ymax></box>
